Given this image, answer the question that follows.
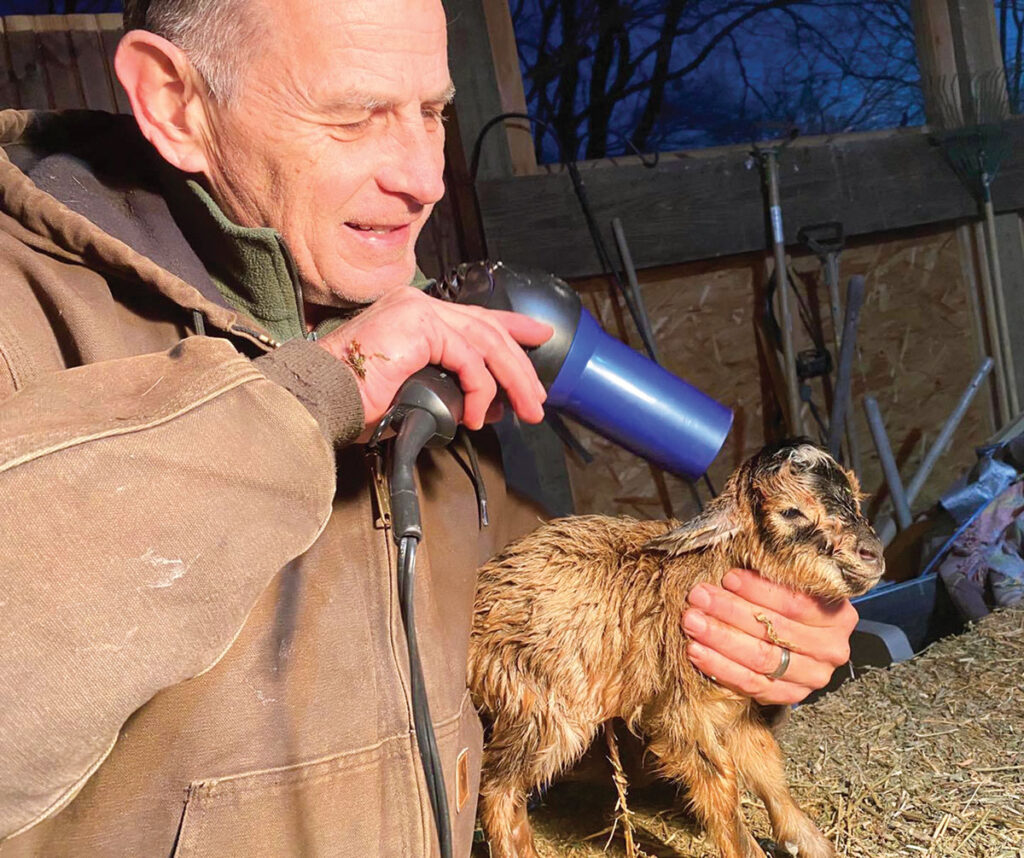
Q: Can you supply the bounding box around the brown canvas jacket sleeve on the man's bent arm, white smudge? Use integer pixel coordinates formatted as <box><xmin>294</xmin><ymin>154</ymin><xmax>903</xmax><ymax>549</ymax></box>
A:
<box><xmin>0</xmin><ymin>337</ymin><xmax>335</xmax><ymax>840</ymax></box>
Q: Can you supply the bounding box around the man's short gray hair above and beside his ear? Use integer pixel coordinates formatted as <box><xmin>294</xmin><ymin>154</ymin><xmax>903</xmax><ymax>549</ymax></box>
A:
<box><xmin>124</xmin><ymin>0</ymin><xmax>262</xmax><ymax>101</ymax></box>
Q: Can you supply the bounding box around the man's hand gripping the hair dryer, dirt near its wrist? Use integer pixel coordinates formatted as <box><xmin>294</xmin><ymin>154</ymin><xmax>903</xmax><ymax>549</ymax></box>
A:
<box><xmin>317</xmin><ymin>287</ymin><xmax>553</xmax><ymax>439</ymax></box>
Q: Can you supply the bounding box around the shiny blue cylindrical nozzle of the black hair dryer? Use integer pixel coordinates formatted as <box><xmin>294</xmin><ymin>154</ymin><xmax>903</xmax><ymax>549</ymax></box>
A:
<box><xmin>548</xmin><ymin>309</ymin><xmax>732</xmax><ymax>479</ymax></box>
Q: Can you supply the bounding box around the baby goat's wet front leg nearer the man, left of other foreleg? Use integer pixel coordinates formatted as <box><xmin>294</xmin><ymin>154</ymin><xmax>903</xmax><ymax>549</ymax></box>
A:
<box><xmin>650</xmin><ymin>735</ymin><xmax>764</xmax><ymax>858</ymax></box>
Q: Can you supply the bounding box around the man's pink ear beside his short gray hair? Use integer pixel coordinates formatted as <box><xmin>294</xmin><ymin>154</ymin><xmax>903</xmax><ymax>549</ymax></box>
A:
<box><xmin>114</xmin><ymin>30</ymin><xmax>209</xmax><ymax>173</ymax></box>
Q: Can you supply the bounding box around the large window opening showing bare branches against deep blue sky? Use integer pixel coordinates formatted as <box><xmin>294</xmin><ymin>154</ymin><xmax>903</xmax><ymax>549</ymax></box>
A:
<box><xmin>511</xmin><ymin>0</ymin><xmax>925</xmax><ymax>163</ymax></box>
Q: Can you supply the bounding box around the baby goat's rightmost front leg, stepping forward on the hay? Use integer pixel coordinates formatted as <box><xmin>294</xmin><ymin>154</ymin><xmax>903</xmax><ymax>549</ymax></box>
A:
<box><xmin>727</xmin><ymin>722</ymin><xmax>836</xmax><ymax>858</ymax></box>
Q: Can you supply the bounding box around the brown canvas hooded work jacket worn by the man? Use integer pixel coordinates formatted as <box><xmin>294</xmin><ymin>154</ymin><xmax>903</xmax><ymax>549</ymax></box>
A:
<box><xmin>0</xmin><ymin>112</ymin><xmax>536</xmax><ymax>858</ymax></box>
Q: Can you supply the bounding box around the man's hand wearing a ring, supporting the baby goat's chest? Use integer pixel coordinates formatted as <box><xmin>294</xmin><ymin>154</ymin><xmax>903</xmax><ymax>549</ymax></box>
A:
<box><xmin>683</xmin><ymin>569</ymin><xmax>857</xmax><ymax>704</ymax></box>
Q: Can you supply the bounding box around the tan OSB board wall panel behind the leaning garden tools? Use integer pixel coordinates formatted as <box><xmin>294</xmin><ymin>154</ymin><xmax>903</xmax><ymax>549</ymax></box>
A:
<box><xmin>570</xmin><ymin>225</ymin><xmax>992</xmax><ymax>532</ymax></box>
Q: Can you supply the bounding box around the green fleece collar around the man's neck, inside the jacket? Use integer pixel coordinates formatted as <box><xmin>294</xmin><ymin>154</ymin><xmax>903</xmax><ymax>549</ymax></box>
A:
<box><xmin>174</xmin><ymin>179</ymin><xmax>434</xmax><ymax>342</ymax></box>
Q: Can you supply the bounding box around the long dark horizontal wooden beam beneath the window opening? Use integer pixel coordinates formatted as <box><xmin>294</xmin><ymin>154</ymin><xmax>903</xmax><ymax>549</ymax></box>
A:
<box><xmin>478</xmin><ymin>120</ymin><xmax>1024</xmax><ymax>277</ymax></box>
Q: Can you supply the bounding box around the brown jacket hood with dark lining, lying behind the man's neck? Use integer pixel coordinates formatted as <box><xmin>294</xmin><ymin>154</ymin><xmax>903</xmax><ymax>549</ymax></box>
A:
<box><xmin>0</xmin><ymin>111</ymin><xmax>272</xmax><ymax>347</ymax></box>
